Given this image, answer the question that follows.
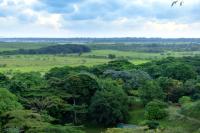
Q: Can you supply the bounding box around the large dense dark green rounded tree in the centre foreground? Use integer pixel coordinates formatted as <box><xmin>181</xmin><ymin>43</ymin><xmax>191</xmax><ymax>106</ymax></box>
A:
<box><xmin>89</xmin><ymin>80</ymin><xmax>128</xmax><ymax>125</ymax></box>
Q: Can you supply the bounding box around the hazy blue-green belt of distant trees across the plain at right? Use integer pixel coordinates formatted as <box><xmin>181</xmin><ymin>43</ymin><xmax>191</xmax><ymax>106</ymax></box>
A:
<box><xmin>88</xmin><ymin>42</ymin><xmax>200</xmax><ymax>53</ymax></box>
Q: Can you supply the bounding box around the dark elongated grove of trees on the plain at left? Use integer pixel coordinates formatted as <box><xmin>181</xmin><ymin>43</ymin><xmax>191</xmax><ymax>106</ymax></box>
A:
<box><xmin>1</xmin><ymin>44</ymin><xmax>90</xmax><ymax>55</ymax></box>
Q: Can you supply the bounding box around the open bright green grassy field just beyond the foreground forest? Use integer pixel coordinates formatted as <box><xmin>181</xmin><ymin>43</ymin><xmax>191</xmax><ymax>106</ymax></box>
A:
<box><xmin>0</xmin><ymin>50</ymin><xmax>200</xmax><ymax>72</ymax></box>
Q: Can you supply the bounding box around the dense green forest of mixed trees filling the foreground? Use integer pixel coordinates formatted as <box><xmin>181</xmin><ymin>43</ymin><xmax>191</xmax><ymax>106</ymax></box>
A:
<box><xmin>0</xmin><ymin>53</ymin><xmax>200</xmax><ymax>133</ymax></box>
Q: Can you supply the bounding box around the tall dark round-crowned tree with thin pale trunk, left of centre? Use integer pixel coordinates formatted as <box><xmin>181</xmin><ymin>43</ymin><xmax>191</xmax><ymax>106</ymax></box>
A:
<box><xmin>65</xmin><ymin>74</ymin><xmax>99</xmax><ymax>124</ymax></box>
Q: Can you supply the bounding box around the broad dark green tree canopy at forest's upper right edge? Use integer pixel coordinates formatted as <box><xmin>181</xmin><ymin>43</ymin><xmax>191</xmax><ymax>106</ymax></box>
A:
<box><xmin>141</xmin><ymin>57</ymin><xmax>197</xmax><ymax>81</ymax></box>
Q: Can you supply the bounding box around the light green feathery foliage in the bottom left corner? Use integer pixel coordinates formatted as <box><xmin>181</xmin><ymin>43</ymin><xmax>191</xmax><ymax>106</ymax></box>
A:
<box><xmin>1</xmin><ymin>110</ymin><xmax>83</xmax><ymax>133</ymax></box>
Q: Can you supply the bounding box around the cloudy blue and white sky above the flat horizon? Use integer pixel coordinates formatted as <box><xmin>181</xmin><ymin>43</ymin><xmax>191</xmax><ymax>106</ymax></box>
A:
<box><xmin>0</xmin><ymin>0</ymin><xmax>200</xmax><ymax>38</ymax></box>
